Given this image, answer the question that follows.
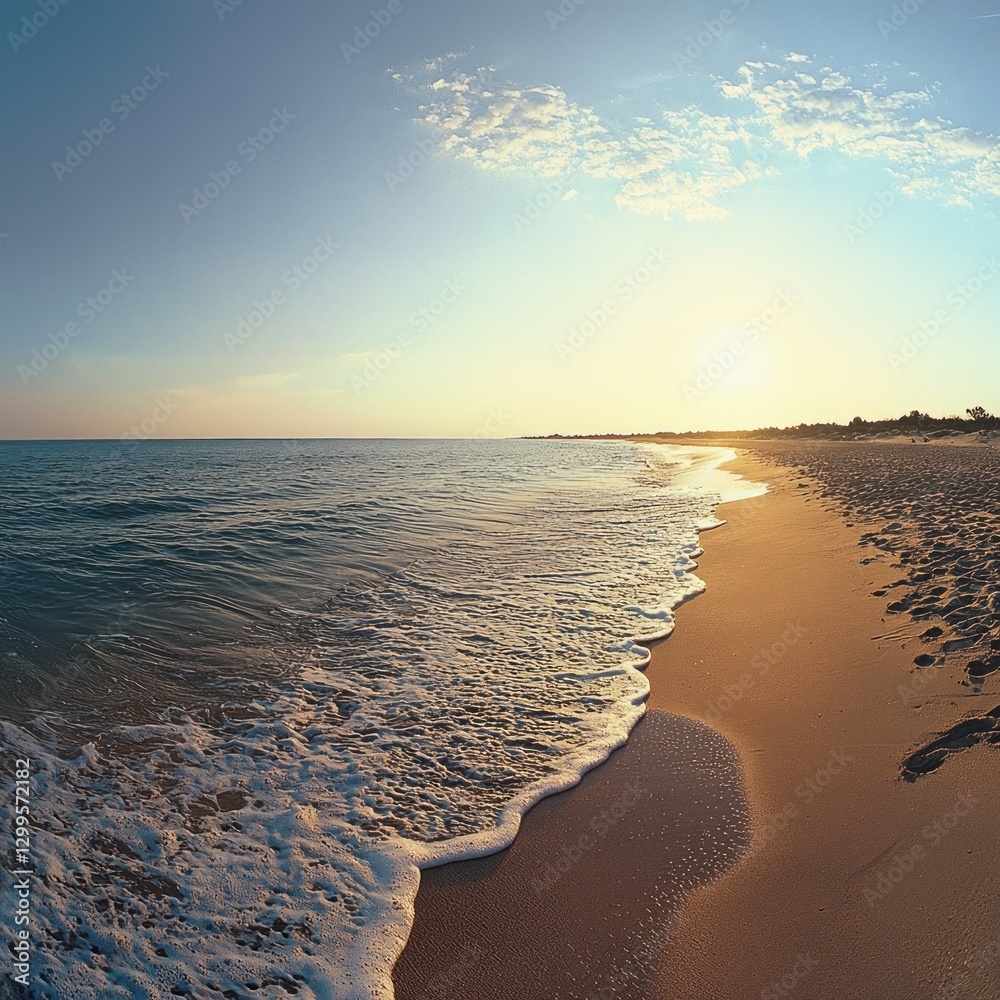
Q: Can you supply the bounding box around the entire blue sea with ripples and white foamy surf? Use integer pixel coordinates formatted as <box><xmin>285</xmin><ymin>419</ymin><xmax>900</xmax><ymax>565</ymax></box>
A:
<box><xmin>0</xmin><ymin>440</ymin><xmax>758</xmax><ymax>1000</ymax></box>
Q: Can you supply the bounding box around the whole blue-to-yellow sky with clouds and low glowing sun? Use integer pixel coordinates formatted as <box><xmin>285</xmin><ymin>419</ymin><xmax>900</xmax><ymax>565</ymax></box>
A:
<box><xmin>0</xmin><ymin>0</ymin><xmax>1000</xmax><ymax>439</ymax></box>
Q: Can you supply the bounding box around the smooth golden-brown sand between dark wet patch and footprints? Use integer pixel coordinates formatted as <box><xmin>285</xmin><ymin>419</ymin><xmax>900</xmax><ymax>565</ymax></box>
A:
<box><xmin>650</xmin><ymin>459</ymin><xmax>1000</xmax><ymax>1000</ymax></box>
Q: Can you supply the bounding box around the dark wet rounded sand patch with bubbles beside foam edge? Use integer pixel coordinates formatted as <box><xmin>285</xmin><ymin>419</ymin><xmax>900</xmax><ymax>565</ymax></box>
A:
<box><xmin>394</xmin><ymin>710</ymin><xmax>749</xmax><ymax>1000</ymax></box>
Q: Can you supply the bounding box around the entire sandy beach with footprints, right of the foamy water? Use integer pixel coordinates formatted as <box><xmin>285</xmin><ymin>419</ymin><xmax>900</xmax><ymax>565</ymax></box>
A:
<box><xmin>395</xmin><ymin>443</ymin><xmax>1000</xmax><ymax>1000</ymax></box>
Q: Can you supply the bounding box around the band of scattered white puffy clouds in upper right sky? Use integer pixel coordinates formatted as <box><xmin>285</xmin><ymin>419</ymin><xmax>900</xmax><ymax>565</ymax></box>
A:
<box><xmin>395</xmin><ymin>53</ymin><xmax>1000</xmax><ymax>219</ymax></box>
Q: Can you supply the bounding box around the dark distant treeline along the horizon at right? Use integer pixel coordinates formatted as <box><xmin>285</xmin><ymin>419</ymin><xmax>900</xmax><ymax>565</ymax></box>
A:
<box><xmin>528</xmin><ymin>406</ymin><xmax>1000</xmax><ymax>441</ymax></box>
